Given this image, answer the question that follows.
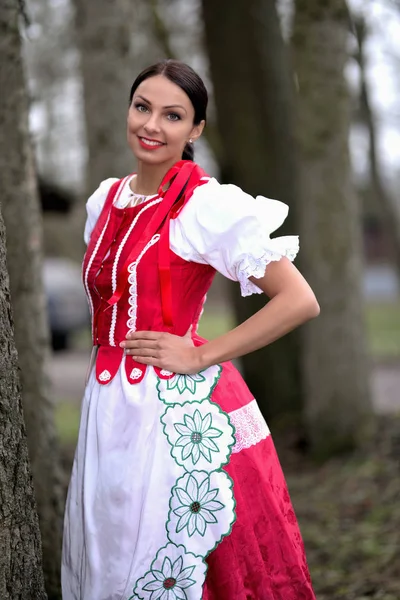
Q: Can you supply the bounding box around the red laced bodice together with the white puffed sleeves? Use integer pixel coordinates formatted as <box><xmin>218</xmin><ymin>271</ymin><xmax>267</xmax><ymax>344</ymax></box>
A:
<box><xmin>83</xmin><ymin>161</ymin><xmax>298</xmax><ymax>384</ymax></box>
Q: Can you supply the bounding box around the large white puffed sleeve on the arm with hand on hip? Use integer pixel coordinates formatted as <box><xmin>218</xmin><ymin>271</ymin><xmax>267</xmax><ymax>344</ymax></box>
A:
<box><xmin>170</xmin><ymin>179</ymin><xmax>299</xmax><ymax>296</ymax></box>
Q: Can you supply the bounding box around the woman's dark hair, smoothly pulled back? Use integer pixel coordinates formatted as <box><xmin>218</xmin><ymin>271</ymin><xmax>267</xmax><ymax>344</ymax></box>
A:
<box><xmin>129</xmin><ymin>59</ymin><xmax>208</xmax><ymax>160</ymax></box>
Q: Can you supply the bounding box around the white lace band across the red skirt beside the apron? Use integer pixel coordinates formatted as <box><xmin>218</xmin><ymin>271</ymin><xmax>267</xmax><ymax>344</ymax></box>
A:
<box><xmin>229</xmin><ymin>400</ymin><xmax>270</xmax><ymax>454</ymax></box>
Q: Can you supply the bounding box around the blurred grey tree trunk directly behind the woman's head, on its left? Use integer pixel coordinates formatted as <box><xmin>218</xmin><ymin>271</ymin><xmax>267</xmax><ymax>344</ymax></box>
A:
<box><xmin>73</xmin><ymin>0</ymin><xmax>136</xmax><ymax>193</ymax></box>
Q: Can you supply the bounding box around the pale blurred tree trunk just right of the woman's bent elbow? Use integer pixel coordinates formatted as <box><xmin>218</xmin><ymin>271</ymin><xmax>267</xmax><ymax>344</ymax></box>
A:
<box><xmin>292</xmin><ymin>0</ymin><xmax>371</xmax><ymax>457</ymax></box>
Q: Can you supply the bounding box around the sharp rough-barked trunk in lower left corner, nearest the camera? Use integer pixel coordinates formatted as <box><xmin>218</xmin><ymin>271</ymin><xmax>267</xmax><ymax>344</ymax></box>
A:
<box><xmin>0</xmin><ymin>191</ymin><xmax>47</xmax><ymax>600</ymax></box>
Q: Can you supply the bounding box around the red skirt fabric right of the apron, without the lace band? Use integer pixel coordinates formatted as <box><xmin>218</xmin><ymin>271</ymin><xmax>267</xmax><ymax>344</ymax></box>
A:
<box><xmin>203</xmin><ymin>363</ymin><xmax>315</xmax><ymax>600</ymax></box>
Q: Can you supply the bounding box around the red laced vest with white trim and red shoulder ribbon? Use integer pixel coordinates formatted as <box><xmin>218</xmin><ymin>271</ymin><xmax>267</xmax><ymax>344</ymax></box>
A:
<box><xmin>83</xmin><ymin>161</ymin><xmax>215</xmax><ymax>384</ymax></box>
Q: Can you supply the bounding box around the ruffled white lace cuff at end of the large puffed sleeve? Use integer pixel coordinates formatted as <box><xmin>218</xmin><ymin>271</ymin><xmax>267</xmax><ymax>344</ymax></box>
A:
<box><xmin>235</xmin><ymin>236</ymin><xmax>299</xmax><ymax>297</ymax></box>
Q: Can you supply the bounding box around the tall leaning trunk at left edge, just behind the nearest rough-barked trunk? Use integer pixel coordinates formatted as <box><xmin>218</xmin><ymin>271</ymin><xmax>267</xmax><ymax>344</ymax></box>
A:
<box><xmin>0</xmin><ymin>0</ymin><xmax>62</xmax><ymax>600</ymax></box>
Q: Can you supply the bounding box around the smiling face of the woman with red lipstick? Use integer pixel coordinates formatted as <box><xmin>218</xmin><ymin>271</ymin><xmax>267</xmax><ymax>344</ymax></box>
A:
<box><xmin>127</xmin><ymin>75</ymin><xmax>204</xmax><ymax>165</ymax></box>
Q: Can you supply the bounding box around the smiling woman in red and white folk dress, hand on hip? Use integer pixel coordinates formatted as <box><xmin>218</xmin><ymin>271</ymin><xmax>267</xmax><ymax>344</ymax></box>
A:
<box><xmin>62</xmin><ymin>61</ymin><xmax>319</xmax><ymax>600</ymax></box>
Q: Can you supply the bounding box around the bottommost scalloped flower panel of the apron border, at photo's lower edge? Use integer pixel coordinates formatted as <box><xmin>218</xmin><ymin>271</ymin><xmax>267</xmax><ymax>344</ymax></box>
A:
<box><xmin>133</xmin><ymin>544</ymin><xmax>207</xmax><ymax>600</ymax></box>
